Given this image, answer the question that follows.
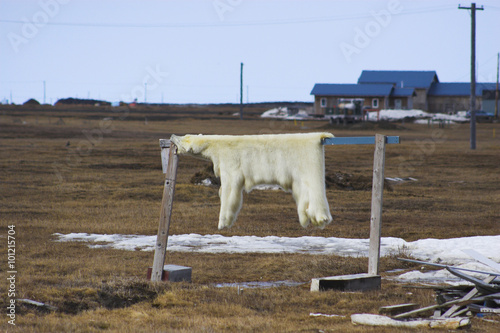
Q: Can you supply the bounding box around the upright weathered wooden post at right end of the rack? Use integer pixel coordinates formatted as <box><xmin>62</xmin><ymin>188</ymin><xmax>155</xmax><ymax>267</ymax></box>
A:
<box><xmin>368</xmin><ymin>134</ymin><xmax>386</xmax><ymax>275</ymax></box>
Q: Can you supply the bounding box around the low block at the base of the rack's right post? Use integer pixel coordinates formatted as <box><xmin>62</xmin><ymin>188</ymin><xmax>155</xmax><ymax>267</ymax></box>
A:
<box><xmin>311</xmin><ymin>274</ymin><xmax>382</xmax><ymax>291</ymax></box>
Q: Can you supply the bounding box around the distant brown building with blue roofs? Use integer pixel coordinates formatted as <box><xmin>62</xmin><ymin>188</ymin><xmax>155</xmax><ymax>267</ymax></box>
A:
<box><xmin>311</xmin><ymin>70</ymin><xmax>495</xmax><ymax>115</ymax></box>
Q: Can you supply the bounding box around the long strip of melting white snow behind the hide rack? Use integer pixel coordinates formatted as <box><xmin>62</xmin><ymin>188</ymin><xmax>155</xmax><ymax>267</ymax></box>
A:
<box><xmin>55</xmin><ymin>233</ymin><xmax>500</xmax><ymax>283</ymax></box>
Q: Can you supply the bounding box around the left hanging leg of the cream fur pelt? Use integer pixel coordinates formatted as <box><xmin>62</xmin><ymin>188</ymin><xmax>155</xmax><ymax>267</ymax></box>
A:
<box><xmin>219</xmin><ymin>178</ymin><xmax>243</xmax><ymax>230</ymax></box>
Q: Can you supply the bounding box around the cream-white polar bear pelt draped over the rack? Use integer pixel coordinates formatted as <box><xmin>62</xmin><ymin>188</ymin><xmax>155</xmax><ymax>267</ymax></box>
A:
<box><xmin>170</xmin><ymin>133</ymin><xmax>333</xmax><ymax>229</ymax></box>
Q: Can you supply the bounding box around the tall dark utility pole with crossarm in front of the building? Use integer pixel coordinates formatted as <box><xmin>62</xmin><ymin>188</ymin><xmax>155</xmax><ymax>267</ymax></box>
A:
<box><xmin>458</xmin><ymin>2</ymin><xmax>484</xmax><ymax>150</ymax></box>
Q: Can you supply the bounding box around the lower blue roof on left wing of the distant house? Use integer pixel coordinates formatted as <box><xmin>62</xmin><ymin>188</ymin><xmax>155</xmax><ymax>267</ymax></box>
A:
<box><xmin>311</xmin><ymin>83</ymin><xmax>392</xmax><ymax>97</ymax></box>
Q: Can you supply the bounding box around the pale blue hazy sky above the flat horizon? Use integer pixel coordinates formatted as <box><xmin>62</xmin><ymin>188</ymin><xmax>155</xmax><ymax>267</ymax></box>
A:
<box><xmin>0</xmin><ymin>0</ymin><xmax>500</xmax><ymax>103</ymax></box>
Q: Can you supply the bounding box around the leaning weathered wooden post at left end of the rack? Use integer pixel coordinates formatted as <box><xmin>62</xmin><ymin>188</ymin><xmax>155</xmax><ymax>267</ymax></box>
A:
<box><xmin>151</xmin><ymin>140</ymin><xmax>179</xmax><ymax>281</ymax></box>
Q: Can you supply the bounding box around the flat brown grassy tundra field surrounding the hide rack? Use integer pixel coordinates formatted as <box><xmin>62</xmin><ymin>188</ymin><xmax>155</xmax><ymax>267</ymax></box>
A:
<box><xmin>0</xmin><ymin>105</ymin><xmax>500</xmax><ymax>333</ymax></box>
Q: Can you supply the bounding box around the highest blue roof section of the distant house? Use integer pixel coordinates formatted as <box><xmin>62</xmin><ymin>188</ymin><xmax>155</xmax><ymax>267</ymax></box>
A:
<box><xmin>358</xmin><ymin>71</ymin><xmax>439</xmax><ymax>88</ymax></box>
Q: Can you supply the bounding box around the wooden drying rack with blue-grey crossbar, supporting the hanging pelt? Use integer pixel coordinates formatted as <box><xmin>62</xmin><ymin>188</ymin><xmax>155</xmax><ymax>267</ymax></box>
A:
<box><xmin>151</xmin><ymin>134</ymin><xmax>399</xmax><ymax>281</ymax></box>
